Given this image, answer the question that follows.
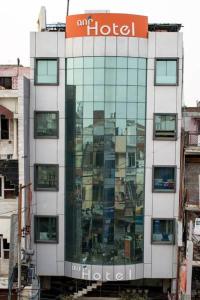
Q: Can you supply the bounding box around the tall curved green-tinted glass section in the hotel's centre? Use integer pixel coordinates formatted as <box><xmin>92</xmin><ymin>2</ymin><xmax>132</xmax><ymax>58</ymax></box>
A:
<box><xmin>65</xmin><ymin>57</ymin><xmax>146</xmax><ymax>265</ymax></box>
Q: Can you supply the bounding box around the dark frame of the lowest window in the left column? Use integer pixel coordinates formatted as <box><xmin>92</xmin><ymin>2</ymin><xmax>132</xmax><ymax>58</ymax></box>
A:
<box><xmin>34</xmin><ymin>215</ymin><xmax>59</xmax><ymax>244</ymax></box>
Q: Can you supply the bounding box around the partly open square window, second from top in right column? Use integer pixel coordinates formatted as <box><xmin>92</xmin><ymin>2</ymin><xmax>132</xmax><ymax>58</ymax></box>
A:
<box><xmin>154</xmin><ymin>114</ymin><xmax>177</xmax><ymax>140</ymax></box>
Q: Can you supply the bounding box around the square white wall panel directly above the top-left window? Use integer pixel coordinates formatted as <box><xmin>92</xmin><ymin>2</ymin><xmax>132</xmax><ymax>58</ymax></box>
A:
<box><xmin>36</xmin><ymin>32</ymin><xmax>58</xmax><ymax>57</ymax></box>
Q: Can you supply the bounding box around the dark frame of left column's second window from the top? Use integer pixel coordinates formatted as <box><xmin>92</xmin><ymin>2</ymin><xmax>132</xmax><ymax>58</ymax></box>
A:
<box><xmin>34</xmin><ymin>110</ymin><xmax>59</xmax><ymax>139</ymax></box>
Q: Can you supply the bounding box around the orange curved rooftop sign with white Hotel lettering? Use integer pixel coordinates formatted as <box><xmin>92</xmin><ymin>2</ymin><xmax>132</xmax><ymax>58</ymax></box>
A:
<box><xmin>65</xmin><ymin>13</ymin><xmax>148</xmax><ymax>38</ymax></box>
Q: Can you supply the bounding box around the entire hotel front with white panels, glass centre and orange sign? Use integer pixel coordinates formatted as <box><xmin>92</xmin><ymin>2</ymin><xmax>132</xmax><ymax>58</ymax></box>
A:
<box><xmin>30</xmin><ymin>12</ymin><xmax>183</xmax><ymax>296</ymax></box>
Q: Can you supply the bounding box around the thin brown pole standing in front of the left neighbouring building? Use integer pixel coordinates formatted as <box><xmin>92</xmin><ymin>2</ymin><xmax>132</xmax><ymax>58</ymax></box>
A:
<box><xmin>17</xmin><ymin>184</ymin><xmax>22</xmax><ymax>300</ymax></box>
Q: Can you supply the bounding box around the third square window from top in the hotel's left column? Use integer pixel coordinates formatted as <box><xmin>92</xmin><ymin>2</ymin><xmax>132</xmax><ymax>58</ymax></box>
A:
<box><xmin>34</xmin><ymin>164</ymin><xmax>58</xmax><ymax>191</ymax></box>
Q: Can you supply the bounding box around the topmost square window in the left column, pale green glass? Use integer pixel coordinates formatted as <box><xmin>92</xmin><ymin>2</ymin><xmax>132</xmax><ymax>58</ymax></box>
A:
<box><xmin>35</xmin><ymin>58</ymin><xmax>58</xmax><ymax>85</ymax></box>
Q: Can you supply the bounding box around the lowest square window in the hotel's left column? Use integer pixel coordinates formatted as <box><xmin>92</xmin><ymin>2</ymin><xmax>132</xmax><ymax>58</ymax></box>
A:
<box><xmin>34</xmin><ymin>216</ymin><xmax>58</xmax><ymax>243</ymax></box>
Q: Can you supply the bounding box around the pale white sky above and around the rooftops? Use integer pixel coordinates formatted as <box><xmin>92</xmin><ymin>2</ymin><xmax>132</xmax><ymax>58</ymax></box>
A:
<box><xmin>0</xmin><ymin>0</ymin><xmax>200</xmax><ymax>106</ymax></box>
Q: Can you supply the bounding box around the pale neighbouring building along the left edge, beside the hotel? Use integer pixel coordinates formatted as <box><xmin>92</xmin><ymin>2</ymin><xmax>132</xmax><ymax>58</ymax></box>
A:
<box><xmin>0</xmin><ymin>65</ymin><xmax>30</xmax><ymax>289</ymax></box>
